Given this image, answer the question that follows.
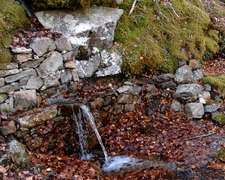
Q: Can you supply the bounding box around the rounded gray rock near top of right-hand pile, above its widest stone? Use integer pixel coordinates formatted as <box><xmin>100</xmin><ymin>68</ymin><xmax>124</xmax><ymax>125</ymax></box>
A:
<box><xmin>175</xmin><ymin>65</ymin><xmax>193</xmax><ymax>83</ymax></box>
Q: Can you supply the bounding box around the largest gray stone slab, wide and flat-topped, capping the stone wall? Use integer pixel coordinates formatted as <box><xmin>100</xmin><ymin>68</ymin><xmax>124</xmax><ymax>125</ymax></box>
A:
<box><xmin>35</xmin><ymin>7</ymin><xmax>123</xmax><ymax>48</ymax></box>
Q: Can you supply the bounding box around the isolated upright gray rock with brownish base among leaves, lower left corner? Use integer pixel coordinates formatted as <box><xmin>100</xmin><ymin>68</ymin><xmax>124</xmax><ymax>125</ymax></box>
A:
<box><xmin>8</xmin><ymin>140</ymin><xmax>30</xmax><ymax>168</ymax></box>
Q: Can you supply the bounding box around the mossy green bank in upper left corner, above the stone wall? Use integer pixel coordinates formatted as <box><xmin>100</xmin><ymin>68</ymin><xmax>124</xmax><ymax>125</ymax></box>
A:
<box><xmin>0</xmin><ymin>0</ymin><xmax>29</xmax><ymax>63</ymax></box>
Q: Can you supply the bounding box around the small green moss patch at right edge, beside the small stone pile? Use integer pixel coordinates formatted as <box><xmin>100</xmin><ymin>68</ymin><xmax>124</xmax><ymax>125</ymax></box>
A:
<box><xmin>203</xmin><ymin>75</ymin><xmax>225</xmax><ymax>95</ymax></box>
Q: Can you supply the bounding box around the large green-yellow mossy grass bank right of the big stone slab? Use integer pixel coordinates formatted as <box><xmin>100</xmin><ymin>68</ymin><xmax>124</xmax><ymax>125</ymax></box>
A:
<box><xmin>115</xmin><ymin>0</ymin><xmax>221</xmax><ymax>74</ymax></box>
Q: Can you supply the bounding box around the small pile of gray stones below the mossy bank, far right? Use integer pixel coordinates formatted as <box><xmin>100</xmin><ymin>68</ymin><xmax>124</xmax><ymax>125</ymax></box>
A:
<box><xmin>171</xmin><ymin>59</ymin><xmax>219</xmax><ymax>119</ymax></box>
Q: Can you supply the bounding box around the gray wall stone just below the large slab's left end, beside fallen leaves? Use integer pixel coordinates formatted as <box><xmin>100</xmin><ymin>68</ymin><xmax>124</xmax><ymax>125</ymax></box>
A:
<box><xmin>30</xmin><ymin>37</ymin><xmax>56</xmax><ymax>57</ymax></box>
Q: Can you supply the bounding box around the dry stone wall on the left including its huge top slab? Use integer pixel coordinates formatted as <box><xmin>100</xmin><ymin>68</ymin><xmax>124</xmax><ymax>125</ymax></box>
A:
<box><xmin>0</xmin><ymin>7</ymin><xmax>123</xmax><ymax>112</ymax></box>
